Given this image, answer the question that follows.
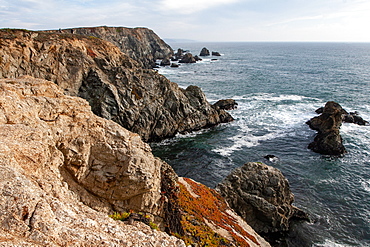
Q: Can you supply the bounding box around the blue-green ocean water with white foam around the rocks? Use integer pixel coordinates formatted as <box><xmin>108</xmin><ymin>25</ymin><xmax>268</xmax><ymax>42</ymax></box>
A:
<box><xmin>152</xmin><ymin>43</ymin><xmax>370</xmax><ymax>247</ymax></box>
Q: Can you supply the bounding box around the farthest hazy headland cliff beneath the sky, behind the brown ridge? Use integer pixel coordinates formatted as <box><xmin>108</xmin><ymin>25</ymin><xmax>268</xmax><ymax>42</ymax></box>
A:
<box><xmin>54</xmin><ymin>26</ymin><xmax>173</xmax><ymax>69</ymax></box>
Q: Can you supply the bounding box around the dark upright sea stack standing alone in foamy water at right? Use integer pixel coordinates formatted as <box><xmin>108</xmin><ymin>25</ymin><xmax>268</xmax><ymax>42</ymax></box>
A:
<box><xmin>307</xmin><ymin>101</ymin><xmax>347</xmax><ymax>155</ymax></box>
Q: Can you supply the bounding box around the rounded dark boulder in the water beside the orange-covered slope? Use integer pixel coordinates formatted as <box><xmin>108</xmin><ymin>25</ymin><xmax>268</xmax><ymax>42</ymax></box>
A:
<box><xmin>216</xmin><ymin>162</ymin><xmax>307</xmax><ymax>234</ymax></box>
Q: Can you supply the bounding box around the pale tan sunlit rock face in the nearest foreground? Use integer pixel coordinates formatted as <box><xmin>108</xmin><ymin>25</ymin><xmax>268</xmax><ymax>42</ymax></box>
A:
<box><xmin>0</xmin><ymin>77</ymin><xmax>185</xmax><ymax>247</ymax></box>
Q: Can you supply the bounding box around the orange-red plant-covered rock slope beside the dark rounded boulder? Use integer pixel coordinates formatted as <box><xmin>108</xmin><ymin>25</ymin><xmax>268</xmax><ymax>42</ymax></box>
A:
<box><xmin>179</xmin><ymin>178</ymin><xmax>260</xmax><ymax>246</ymax></box>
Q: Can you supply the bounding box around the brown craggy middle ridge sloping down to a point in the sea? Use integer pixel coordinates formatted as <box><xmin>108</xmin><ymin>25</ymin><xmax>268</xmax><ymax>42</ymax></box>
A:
<box><xmin>0</xmin><ymin>27</ymin><xmax>230</xmax><ymax>141</ymax></box>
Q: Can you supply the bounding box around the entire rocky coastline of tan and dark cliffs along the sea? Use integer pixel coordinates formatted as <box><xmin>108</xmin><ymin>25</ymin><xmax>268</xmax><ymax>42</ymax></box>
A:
<box><xmin>0</xmin><ymin>27</ymin><xmax>307</xmax><ymax>246</ymax></box>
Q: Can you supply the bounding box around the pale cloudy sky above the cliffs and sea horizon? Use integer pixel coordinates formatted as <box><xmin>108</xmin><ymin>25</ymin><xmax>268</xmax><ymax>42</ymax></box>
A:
<box><xmin>0</xmin><ymin>0</ymin><xmax>370</xmax><ymax>42</ymax></box>
